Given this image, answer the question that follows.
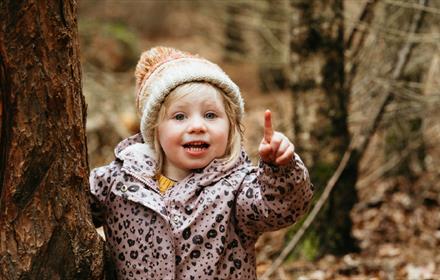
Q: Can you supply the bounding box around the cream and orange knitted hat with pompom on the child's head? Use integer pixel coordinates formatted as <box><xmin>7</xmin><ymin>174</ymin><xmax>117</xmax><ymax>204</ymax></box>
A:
<box><xmin>135</xmin><ymin>47</ymin><xmax>244</xmax><ymax>147</ymax></box>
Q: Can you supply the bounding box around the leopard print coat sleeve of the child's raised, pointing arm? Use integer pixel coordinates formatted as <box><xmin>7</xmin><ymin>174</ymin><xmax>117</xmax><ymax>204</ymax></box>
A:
<box><xmin>235</xmin><ymin>154</ymin><xmax>313</xmax><ymax>239</ymax></box>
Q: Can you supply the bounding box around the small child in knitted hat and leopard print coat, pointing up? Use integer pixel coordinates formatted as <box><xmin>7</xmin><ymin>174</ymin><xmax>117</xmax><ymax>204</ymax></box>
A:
<box><xmin>90</xmin><ymin>47</ymin><xmax>312</xmax><ymax>280</ymax></box>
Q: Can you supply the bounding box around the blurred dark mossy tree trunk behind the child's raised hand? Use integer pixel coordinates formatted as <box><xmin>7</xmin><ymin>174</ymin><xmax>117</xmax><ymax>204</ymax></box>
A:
<box><xmin>290</xmin><ymin>0</ymin><xmax>359</xmax><ymax>258</ymax></box>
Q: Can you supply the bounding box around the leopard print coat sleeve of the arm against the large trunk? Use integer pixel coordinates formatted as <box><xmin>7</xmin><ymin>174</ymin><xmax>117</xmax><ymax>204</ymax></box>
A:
<box><xmin>89</xmin><ymin>161</ymin><xmax>117</xmax><ymax>227</ymax></box>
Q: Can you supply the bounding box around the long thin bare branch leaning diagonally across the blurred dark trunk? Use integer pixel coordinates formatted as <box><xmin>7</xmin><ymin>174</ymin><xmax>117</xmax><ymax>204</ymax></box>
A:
<box><xmin>261</xmin><ymin>0</ymin><xmax>426</xmax><ymax>280</ymax></box>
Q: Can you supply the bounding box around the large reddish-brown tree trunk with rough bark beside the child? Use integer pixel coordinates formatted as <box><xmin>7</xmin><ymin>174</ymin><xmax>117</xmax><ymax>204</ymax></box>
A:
<box><xmin>0</xmin><ymin>0</ymin><xmax>103</xmax><ymax>279</ymax></box>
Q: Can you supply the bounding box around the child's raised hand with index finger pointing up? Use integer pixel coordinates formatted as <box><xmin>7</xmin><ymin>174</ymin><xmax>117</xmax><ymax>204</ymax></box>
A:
<box><xmin>258</xmin><ymin>110</ymin><xmax>295</xmax><ymax>165</ymax></box>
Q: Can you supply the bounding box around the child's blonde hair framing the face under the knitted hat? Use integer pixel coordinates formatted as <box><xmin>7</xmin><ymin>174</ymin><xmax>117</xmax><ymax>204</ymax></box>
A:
<box><xmin>150</xmin><ymin>82</ymin><xmax>243</xmax><ymax>174</ymax></box>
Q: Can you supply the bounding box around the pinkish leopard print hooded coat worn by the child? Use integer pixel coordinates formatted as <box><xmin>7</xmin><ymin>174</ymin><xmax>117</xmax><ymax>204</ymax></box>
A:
<box><xmin>90</xmin><ymin>134</ymin><xmax>313</xmax><ymax>280</ymax></box>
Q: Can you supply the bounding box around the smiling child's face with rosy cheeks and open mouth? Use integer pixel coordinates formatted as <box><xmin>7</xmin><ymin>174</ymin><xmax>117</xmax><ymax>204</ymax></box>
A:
<box><xmin>158</xmin><ymin>87</ymin><xmax>230</xmax><ymax>180</ymax></box>
